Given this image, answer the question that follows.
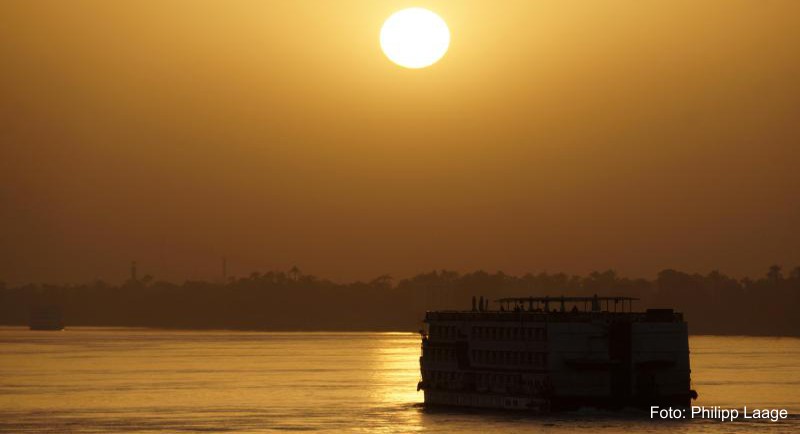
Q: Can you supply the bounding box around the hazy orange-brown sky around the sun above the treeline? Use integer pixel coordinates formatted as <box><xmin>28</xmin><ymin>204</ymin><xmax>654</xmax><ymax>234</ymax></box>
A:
<box><xmin>0</xmin><ymin>0</ymin><xmax>800</xmax><ymax>284</ymax></box>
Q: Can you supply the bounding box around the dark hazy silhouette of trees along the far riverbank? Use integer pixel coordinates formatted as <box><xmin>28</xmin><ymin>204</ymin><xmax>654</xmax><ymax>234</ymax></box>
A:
<box><xmin>0</xmin><ymin>266</ymin><xmax>800</xmax><ymax>336</ymax></box>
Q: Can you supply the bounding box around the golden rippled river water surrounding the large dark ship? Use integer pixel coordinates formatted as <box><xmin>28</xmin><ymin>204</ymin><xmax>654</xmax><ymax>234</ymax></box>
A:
<box><xmin>0</xmin><ymin>327</ymin><xmax>800</xmax><ymax>433</ymax></box>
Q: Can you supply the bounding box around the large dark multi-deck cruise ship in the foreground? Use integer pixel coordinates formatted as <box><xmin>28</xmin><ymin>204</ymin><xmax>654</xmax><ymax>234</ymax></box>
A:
<box><xmin>417</xmin><ymin>295</ymin><xmax>697</xmax><ymax>413</ymax></box>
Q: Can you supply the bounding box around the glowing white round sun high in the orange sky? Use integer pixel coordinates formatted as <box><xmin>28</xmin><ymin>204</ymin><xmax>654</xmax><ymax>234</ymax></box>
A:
<box><xmin>381</xmin><ymin>8</ymin><xmax>450</xmax><ymax>69</ymax></box>
